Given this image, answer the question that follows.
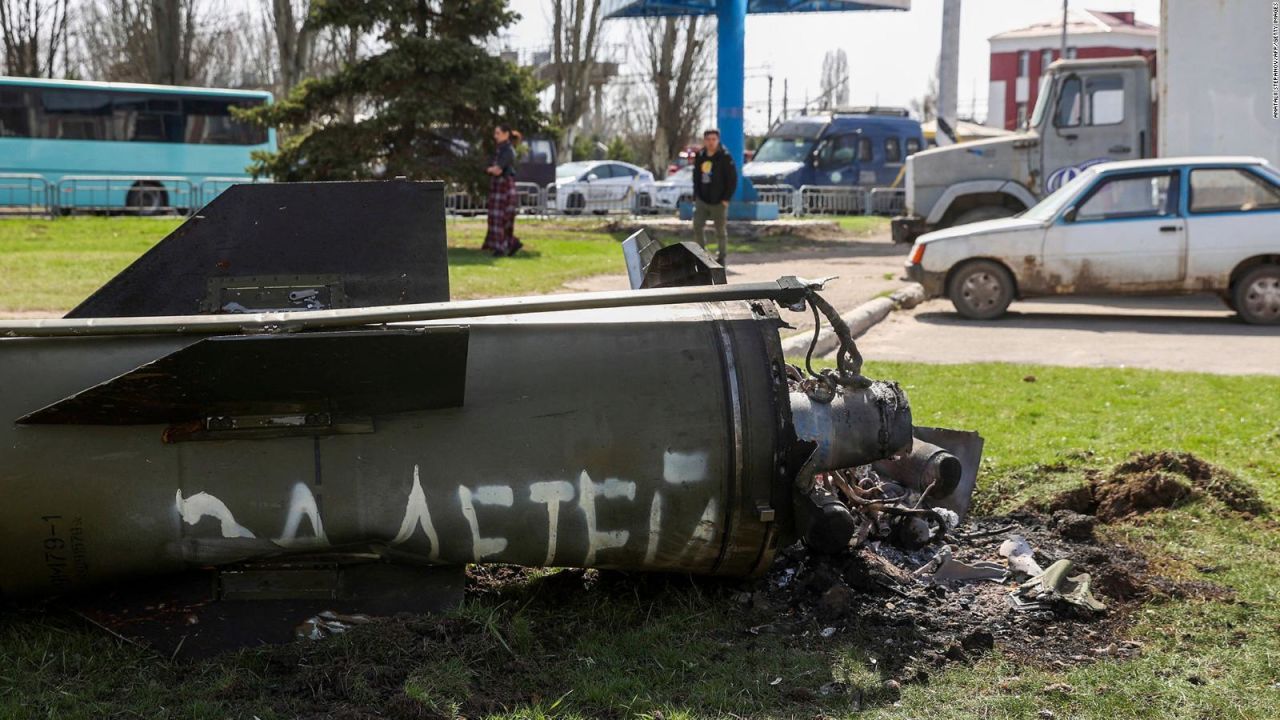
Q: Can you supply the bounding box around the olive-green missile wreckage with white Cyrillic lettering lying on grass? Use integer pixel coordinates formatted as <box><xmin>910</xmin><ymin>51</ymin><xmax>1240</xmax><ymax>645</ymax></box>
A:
<box><xmin>0</xmin><ymin>181</ymin><xmax>980</xmax><ymax>622</ymax></box>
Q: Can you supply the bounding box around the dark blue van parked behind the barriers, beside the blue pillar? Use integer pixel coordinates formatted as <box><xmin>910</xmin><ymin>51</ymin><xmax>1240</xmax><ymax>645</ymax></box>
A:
<box><xmin>742</xmin><ymin>108</ymin><xmax>924</xmax><ymax>187</ymax></box>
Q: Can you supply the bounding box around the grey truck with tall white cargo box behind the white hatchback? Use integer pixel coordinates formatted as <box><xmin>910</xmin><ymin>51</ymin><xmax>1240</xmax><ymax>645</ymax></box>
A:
<box><xmin>892</xmin><ymin>0</ymin><xmax>1280</xmax><ymax>242</ymax></box>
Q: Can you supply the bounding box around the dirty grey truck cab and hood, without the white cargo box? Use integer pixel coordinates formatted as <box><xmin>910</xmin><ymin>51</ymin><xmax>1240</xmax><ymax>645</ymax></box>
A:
<box><xmin>892</xmin><ymin>58</ymin><xmax>1153</xmax><ymax>242</ymax></box>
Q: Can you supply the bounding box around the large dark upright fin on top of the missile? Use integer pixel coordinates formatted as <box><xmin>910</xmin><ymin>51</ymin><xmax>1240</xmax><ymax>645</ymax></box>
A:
<box><xmin>67</xmin><ymin>181</ymin><xmax>449</xmax><ymax>318</ymax></box>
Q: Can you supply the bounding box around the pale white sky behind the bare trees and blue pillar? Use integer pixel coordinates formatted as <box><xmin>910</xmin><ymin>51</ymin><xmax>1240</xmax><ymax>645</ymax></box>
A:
<box><xmin>503</xmin><ymin>0</ymin><xmax>1160</xmax><ymax>132</ymax></box>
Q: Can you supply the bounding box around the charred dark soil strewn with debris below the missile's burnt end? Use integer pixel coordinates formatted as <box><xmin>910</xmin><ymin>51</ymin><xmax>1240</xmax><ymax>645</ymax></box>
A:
<box><xmin>751</xmin><ymin>514</ymin><xmax>1230</xmax><ymax>682</ymax></box>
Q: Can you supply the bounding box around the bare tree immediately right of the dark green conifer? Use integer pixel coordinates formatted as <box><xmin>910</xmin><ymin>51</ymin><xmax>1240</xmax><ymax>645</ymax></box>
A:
<box><xmin>550</xmin><ymin>0</ymin><xmax>603</xmax><ymax>159</ymax></box>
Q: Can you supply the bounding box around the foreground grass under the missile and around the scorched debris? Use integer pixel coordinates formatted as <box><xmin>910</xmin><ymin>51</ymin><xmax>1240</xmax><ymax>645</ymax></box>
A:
<box><xmin>0</xmin><ymin>364</ymin><xmax>1280</xmax><ymax>720</ymax></box>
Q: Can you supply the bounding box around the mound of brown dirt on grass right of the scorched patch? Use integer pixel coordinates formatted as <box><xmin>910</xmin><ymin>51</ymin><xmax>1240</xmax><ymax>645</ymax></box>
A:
<box><xmin>1047</xmin><ymin>451</ymin><xmax>1268</xmax><ymax>523</ymax></box>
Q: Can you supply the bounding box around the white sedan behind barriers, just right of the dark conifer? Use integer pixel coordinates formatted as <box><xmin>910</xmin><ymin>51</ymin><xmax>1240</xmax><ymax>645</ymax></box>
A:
<box><xmin>553</xmin><ymin>160</ymin><xmax>658</xmax><ymax>215</ymax></box>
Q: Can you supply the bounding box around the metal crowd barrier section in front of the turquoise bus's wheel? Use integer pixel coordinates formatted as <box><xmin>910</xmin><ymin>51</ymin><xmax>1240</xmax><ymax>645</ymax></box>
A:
<box><xmin>56</xmin><ymin>176</ymin><xmax>201</xmax><ymax>215</ymax></box>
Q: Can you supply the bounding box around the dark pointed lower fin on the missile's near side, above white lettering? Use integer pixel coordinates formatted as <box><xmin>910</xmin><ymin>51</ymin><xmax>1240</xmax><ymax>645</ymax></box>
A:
<box><xmin>18</xmin><ymin>327</ymin><xmax>467</xmax><ymax>429</ymax></box>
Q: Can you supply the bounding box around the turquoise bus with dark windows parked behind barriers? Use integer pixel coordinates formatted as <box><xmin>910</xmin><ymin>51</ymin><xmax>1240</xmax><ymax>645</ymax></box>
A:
<box><xmin>0</xmin><ymin>77</ymin><xmax>275</xmax><ymax>214</ymax></box>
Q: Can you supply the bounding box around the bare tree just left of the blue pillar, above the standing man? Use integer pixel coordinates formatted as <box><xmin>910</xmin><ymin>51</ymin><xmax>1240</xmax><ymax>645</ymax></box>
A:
<box><xmin>635</xmin><ymin>15</ymin><xmax>714</xmax><ymax>174</ymax></box>
